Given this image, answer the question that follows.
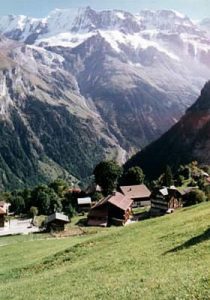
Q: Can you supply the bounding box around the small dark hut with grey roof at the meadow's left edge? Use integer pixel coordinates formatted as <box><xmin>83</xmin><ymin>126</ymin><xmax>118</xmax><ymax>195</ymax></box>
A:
<box><xmin>45</xmin><ymin>212</ymin><xmax>69</xmax><ymax>231</ymax></box>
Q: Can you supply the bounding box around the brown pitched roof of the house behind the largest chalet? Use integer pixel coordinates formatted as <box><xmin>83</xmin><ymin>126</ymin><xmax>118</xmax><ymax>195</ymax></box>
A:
<box><xmin>120</xmin><ymin>184</ymin><xmax>151</xmax><ymax>199</ymax></box>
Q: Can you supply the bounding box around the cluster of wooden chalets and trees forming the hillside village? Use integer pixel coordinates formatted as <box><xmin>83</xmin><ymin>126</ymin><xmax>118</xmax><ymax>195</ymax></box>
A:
<box><xmin>0</xmin><ymin>162</ymin><xmax>210</xmax><ymax>236</ymax></box>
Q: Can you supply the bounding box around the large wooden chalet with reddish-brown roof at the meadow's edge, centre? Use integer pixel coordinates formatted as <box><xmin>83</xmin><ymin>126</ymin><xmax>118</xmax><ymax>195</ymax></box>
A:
<box><xmin>87</xmin><ymin>192</ymin><xmax>133</xmax><ymax>227</ymax></box>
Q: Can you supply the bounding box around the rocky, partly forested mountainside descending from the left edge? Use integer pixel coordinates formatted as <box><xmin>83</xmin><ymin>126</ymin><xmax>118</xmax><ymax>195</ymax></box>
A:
<box><xmin>0</xmin><ymin>39</ymin><xmax>129</xmax><ymax>188</ymax></box>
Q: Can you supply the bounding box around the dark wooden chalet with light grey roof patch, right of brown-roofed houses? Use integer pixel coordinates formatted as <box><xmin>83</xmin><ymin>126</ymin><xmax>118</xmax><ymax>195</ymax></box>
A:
<box><xmin>150</xmin><ymin>186</ymin><xmax>185</xmax><ymax>216</ymax></box>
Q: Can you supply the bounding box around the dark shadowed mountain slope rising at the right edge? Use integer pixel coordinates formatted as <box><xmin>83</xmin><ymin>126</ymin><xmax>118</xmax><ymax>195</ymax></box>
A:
<box><xmin>126</xmin><ymin>81</ymin><xmax>210</xmax><ymax>178</ymax></box>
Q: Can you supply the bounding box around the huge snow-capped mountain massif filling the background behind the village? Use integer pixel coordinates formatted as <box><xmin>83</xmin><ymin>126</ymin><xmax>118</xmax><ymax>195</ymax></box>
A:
<box><xmin>0</xmin><ymin>7</ymin><xmax>210</xmax><ymax>188</ymax></box>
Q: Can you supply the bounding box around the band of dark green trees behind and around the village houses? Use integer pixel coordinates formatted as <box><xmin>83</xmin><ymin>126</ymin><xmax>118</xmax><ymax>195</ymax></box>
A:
<box><xmin>1</xmin><ymin>160</ymin><xmax>210</xmax><ymax>217</ymax></box>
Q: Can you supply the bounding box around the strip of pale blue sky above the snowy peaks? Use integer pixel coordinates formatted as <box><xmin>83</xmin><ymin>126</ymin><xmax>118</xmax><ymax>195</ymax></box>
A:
<box><xmin>0</xmin><ymin>0</ymin><xmax>210</xmax><ymax>20</ymax></box>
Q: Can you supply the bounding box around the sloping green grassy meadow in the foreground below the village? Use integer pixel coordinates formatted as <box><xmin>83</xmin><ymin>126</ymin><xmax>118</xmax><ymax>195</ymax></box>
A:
<box><xmin>0</xmin><ymin>203</ymin><xmax>210</xmax><ymax>300</ymax></box>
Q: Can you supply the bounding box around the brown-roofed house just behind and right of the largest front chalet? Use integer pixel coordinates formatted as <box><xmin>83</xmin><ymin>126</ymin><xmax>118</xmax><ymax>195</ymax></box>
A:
<box><xmin>120</xmin><ymin>184</ymin><xmax>151</xmax><ymax>207</ymax></box>
